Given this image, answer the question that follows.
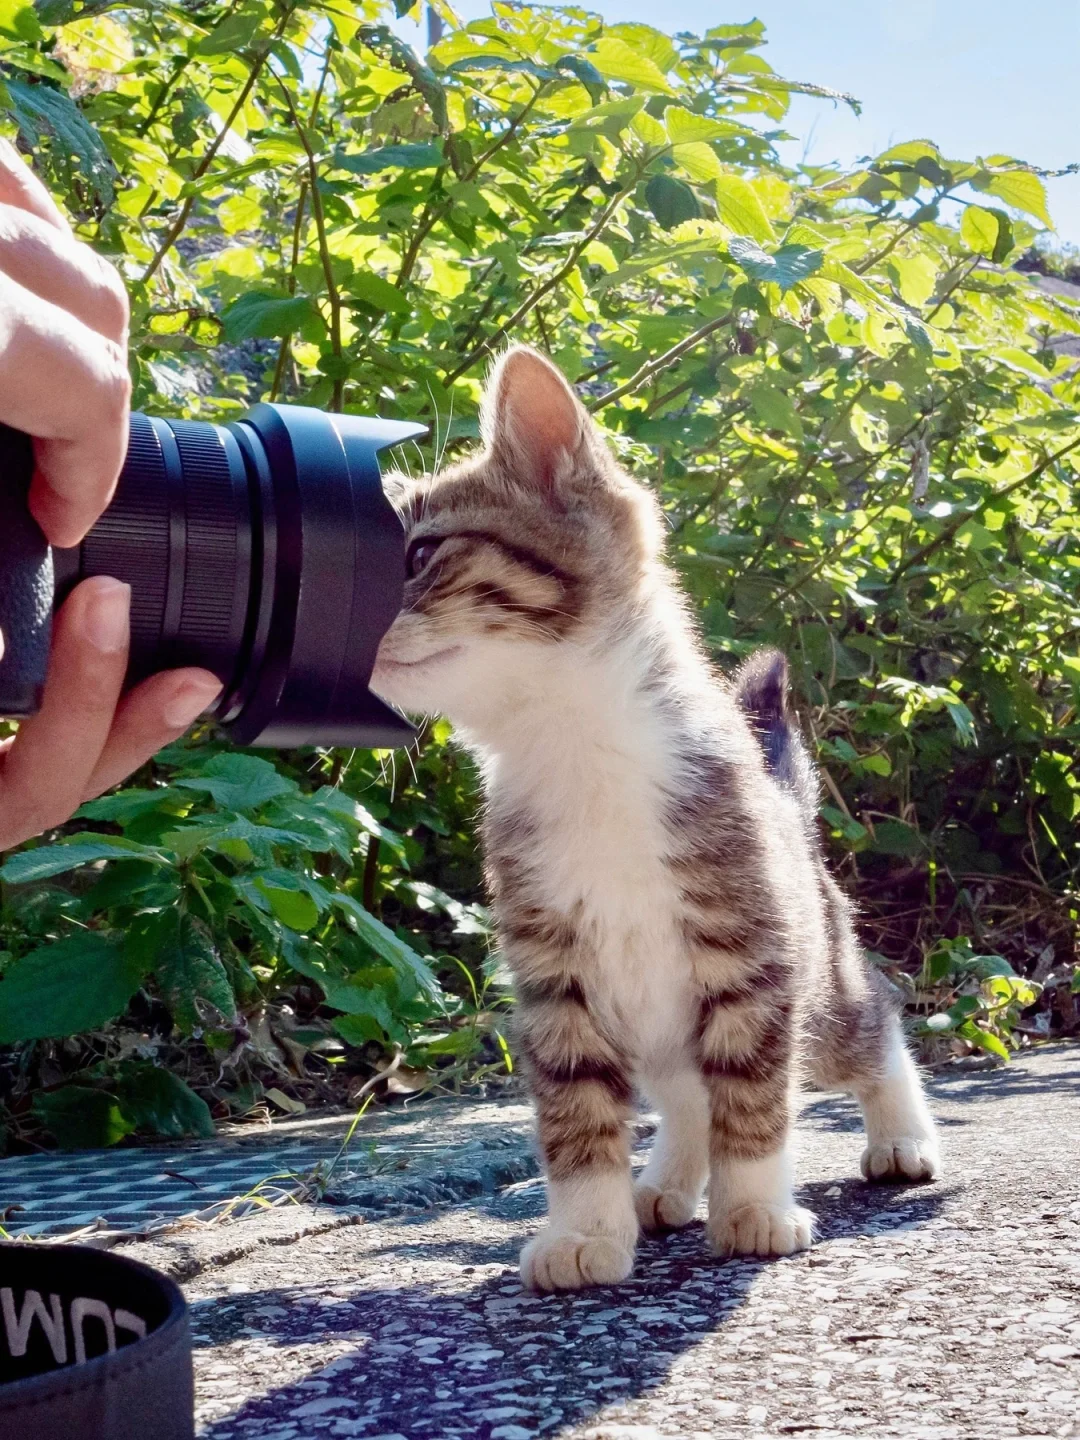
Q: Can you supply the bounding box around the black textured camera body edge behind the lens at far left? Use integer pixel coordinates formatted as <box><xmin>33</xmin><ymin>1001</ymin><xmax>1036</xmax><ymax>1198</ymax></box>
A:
<box><xmin>0</xmin><ymin>425</ymin><xmax>53</xmax><ymax>719</ymax></box>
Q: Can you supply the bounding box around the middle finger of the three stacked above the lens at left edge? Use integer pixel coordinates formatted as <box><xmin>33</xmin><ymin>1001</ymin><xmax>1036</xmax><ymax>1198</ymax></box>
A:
<box><xmin>0</xmin><ymin>203</ymin><xmax>128</xmax><ymax>346</ymax></box>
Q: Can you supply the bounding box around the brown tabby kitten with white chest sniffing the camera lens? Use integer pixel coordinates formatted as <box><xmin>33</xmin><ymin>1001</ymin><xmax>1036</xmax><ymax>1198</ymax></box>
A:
<box><xmin>373</xmin><ymin>348</ymin><xmax>940</xmax><ymax>1290</ymax></box>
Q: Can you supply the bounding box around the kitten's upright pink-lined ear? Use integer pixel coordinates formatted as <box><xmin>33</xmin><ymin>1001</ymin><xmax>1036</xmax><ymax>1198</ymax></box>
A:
<box><xmin>481</xmin><ymin>346</ymin><xmax>589</xmax><ymax>492</ymax></box>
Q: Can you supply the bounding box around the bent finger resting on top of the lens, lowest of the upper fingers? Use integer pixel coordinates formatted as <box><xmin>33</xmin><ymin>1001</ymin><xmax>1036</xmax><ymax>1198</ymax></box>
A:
<box><xmin>0</xmin><ymin>274</ymin><xmax>131</xmax><ymax>546</ymax></box>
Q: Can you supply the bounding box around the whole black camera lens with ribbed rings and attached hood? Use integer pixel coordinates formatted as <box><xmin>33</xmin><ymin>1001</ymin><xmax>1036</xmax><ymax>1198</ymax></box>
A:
<box><xmin>53</xmin><ymin>405</ymin><xmax>425</xmax><ymax>746</ymax></box>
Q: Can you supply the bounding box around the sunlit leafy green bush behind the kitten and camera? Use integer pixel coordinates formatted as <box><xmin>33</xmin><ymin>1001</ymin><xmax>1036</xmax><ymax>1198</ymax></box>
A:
<box><xmin>0</xmin><ymin>0</ymin><xmax>1080</xmax><ymax>1139</ymax></box>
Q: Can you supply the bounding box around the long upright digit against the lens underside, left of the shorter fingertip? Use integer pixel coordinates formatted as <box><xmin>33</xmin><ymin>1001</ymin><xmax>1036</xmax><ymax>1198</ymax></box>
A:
<box><xmin>0</xmin><ymin>575</ymin><xmax>131</xmax><ymax>850</ymax></box>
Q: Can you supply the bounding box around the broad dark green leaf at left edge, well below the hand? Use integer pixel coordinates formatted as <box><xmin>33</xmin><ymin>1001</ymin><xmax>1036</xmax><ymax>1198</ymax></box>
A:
<box><xmin>0</xmin><ymin>930</ymin><xmax>145</xmax><ymax>1045</ymax></box>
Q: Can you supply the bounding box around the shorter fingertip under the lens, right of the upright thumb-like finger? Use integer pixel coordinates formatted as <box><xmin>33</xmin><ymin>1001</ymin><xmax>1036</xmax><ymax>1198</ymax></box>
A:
<box><xmin>84</xmin><ymin>670</ymin><xmax>222</xmax><ymax>799</ymax></box>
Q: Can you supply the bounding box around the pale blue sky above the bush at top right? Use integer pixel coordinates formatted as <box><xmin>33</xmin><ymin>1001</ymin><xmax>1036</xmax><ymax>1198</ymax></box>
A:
<box><xmin>397</xmin><ymin>0</ymin><xmax>1080</xmax><ymax>245</ymax></box>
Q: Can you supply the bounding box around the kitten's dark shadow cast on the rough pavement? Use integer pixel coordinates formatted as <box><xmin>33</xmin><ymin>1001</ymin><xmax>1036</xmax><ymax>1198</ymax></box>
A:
<box><xmin>193</xmin><ymin>1179</ymin><xmax>949</xmax><ymax>1440</ymax></box>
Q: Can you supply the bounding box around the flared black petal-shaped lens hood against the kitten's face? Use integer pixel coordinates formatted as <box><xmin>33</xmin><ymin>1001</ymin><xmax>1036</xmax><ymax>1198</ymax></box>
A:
<box><xmin>219</xmin><ymin>405</ymin><xmax>426</xmax><ymax>746</ymax></box>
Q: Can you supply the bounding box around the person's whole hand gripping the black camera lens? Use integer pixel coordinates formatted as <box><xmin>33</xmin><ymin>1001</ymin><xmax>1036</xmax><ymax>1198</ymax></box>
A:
<box><xmin>0</xmin><ymin>140</ymin><xmax>220</xmax><ymax>850</ymax></box>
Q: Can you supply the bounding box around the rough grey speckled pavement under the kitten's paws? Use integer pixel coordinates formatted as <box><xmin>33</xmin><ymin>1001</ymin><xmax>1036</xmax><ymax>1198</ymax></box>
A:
<box><xmin>180</xmin><ymin>1047</ymin><xmax>1080</xmax><ymax>1440</ymax></box>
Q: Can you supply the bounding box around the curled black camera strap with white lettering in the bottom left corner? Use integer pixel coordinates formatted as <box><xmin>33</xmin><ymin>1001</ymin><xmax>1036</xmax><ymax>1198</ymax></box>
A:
<box><xmin>0</xmin><ymin>1243</ymin><xmax>194</xmax><ymax>1440</ymax></box>
